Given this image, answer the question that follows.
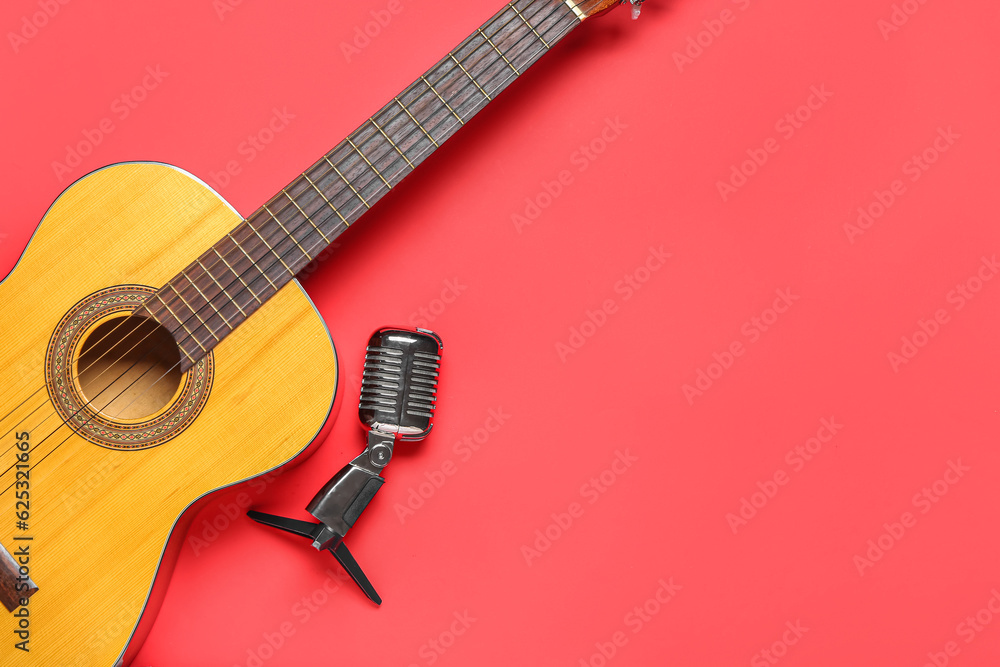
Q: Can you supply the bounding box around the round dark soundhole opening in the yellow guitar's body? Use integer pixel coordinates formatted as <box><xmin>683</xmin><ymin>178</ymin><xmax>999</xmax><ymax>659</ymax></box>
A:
<box><xmin>76</xmin><ymin>317</ymin><xmax>182</xmax><ymax>421</ymax></box>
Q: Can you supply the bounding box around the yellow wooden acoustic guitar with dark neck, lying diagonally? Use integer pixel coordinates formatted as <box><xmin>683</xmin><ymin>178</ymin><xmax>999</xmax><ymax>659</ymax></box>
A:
<box><xmin>0</xmin><ymin>0</ymin><xmax>641</xmax><ymax>667</ymax></box>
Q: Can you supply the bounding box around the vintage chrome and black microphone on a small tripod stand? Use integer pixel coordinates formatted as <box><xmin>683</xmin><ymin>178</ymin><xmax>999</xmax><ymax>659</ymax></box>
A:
<box><xmin>247</xmin><ymin>328</ymin><xmax>443</xmax><ymax>604</ymax></box>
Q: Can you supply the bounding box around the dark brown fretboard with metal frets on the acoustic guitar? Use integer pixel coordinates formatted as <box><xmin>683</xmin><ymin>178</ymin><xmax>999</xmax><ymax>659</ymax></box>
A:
<box><xmin>137</xmin><ymin>0</ymin><xmax>580</xmax><ymax>371</ymax></box>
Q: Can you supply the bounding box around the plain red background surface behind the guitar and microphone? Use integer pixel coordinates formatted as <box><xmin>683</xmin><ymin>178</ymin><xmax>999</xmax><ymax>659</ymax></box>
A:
<box><xmin>0</xmin><ymin>0</ymin><xmax>1000</xmax><ymax>667</ymax></box>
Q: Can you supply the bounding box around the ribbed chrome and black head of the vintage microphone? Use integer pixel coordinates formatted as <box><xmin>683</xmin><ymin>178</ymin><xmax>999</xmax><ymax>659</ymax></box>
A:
<box><xmin>358</xmin><ymin>328</ymin><xmax>444</xmax><ymax>440</ymax></box>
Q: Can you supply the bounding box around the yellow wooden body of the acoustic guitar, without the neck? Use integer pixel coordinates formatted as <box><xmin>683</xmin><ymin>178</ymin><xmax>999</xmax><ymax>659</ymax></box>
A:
<box><xmin>0</xmin><ymin>163</ymin><xmax>337</xmax><ymax>667</ymax></box>
